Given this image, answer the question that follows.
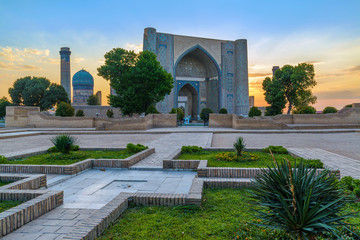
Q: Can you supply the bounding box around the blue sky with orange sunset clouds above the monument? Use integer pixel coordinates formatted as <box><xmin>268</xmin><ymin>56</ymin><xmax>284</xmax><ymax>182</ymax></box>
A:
<box><xmin>0</xmin><ymin>0</ymin><xmax>360</xmax><ymax>110</ymax></box>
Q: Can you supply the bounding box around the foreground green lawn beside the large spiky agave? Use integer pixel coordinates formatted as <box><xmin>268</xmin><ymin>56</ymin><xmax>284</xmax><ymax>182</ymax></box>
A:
<box><xmin>99</xmin><ymin>189</ymin><xmax>360</xmax><ymax>240</ymax></box>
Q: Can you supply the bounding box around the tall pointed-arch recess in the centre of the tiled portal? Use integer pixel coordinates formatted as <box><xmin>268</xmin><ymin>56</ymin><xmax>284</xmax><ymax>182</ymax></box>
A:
<box><xmin>175</xmin><ymin>45</ymin><xmax>220</xmax><ymax>117</ymax></box>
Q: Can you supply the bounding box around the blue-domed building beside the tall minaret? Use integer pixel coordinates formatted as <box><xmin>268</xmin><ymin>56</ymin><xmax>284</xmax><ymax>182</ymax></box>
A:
<box><xmin>72</xmin><ymin>69</ymin><xmax>94</xmax><ymax>105</ymax></box>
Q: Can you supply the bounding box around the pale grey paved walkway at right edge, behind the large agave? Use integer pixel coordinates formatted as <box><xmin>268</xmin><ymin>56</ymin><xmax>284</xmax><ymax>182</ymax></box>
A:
<box><xmin>288</xmin><ymin>148</ymin><xmax>360</xmax><ymax>179</ymax></box>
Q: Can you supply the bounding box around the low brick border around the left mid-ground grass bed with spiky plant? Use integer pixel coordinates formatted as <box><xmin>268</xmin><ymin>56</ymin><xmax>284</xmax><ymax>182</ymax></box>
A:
<box><xmin>0</xmin><ymin>148</ymin><xmax>155</xmax><ymax>175</ymax></box>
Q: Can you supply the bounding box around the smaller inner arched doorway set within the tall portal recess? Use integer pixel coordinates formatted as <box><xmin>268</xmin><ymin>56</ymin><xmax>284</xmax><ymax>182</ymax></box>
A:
<box><xmin>178</xmin><ymin>83</ymin><xmax>199</xmax><ymax>118</ymax></box>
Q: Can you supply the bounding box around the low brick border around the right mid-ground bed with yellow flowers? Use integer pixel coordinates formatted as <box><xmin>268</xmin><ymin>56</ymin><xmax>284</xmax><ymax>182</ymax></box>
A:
<box><xmin>163</xmin><ymin>148</ymin><xmax>340</xmax><ymax>179</ymax></box>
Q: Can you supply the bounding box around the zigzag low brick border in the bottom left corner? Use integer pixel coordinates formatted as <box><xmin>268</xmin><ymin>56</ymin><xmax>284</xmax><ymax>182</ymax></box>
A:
<box><xmin>0</xmin><ymin>173</ymin><xmax>64</xmax><ymax>238</ymax></box>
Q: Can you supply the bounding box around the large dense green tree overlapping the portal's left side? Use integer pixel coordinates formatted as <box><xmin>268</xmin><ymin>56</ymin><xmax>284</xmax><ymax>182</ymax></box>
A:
<box><xmin>98</xmin><ymin>48</ymin><xmax>173</xmax><ymax>116</ymax></box>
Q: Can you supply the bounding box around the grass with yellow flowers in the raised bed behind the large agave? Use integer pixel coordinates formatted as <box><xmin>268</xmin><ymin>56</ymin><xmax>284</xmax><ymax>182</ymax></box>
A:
<box><xmin>178</xmin><ymin>151</ymin><xmax>314</xmax><ymax>168</ymax></box>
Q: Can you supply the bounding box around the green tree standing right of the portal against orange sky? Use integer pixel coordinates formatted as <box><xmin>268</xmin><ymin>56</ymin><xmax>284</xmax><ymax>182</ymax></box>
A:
<box><xmin>263</xmin><ymin>63</ymin><xmax>316</xmax><ymax>114</ymax></box>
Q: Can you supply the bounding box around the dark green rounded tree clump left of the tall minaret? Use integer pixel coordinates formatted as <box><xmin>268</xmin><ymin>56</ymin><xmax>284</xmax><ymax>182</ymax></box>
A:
<box><xmin>9</xmin><ymin>76</ymin><xmax>69</xmax><ymax>110</ymax></box>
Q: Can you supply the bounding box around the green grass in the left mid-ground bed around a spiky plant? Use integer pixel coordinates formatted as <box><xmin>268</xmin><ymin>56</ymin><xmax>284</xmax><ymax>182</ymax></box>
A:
<box><xmin>2</xmin><ymin>150</ymin><xmax>133</xmax><ymax>165</ymax></box>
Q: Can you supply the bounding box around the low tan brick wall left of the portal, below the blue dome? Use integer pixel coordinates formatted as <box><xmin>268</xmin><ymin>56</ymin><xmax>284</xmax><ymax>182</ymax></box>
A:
<box><xmin>5</xmin><ymin>106</ymin><xmax>177</xmax><ymax>130</ymax></box>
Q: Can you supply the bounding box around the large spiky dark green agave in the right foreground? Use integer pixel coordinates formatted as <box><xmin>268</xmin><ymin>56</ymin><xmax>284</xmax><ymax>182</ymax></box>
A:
<box><xmin>249</xmin><ymin>158</ymin><xmax>349</xmax><ymax>239</ymax></box>
